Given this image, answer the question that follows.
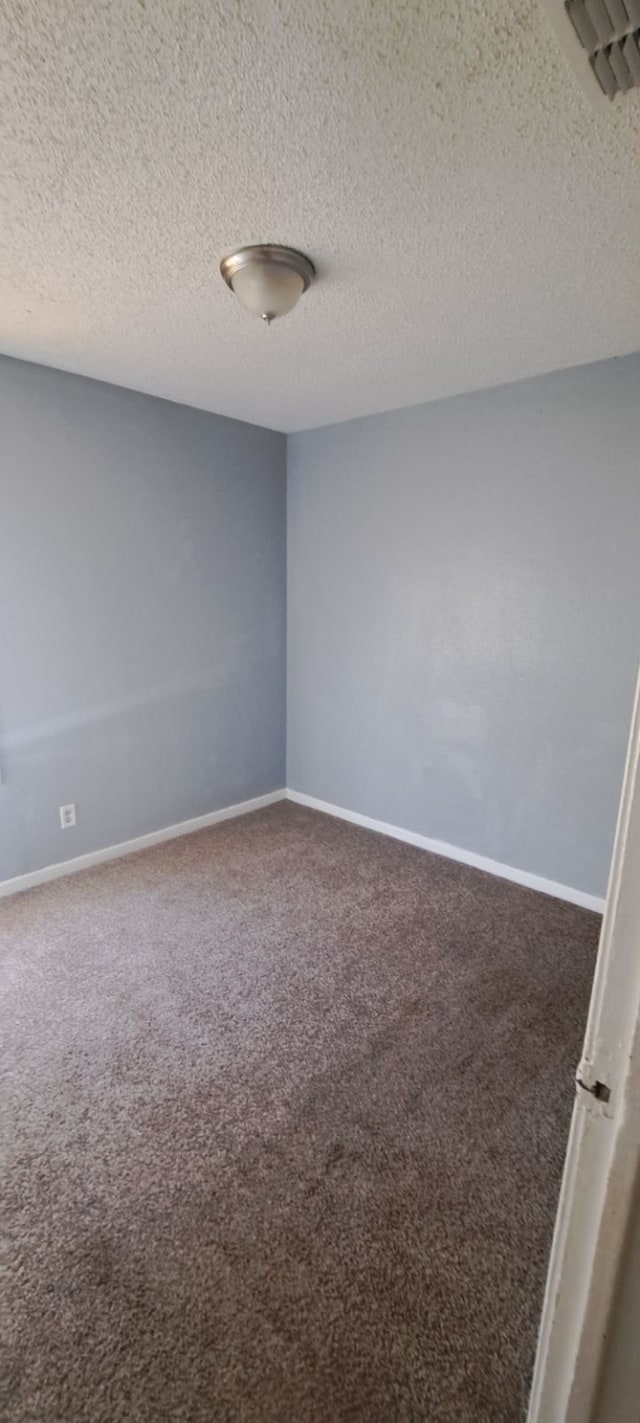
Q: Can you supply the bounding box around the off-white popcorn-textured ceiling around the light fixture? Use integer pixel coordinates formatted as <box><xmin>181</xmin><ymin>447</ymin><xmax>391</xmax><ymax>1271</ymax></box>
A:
<box><xmin>0</xmin><ymin>0</ymin><xmax>640</xmax><ymax>430</ymax></box>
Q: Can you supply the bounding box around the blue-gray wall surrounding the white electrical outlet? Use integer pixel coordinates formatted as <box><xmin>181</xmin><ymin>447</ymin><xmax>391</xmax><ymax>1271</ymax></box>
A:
<box><xmin>0</xmin><ymin>359</ymin><xmax>286</xmax><ymax>879</ymax></box>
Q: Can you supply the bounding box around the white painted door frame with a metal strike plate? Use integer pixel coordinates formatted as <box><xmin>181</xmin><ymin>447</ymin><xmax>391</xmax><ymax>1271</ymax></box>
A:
<box><xmin>528</xmin><ymin>665</ymin><xmax>640</xmax><ymax>1423</ymax></box>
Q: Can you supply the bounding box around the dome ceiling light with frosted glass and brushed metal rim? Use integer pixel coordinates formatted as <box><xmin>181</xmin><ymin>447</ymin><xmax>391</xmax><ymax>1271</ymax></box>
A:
<box><xmin>220</xmin><ymin>242</ymin><xmax>316</xmax><ymax>326</ymax></box>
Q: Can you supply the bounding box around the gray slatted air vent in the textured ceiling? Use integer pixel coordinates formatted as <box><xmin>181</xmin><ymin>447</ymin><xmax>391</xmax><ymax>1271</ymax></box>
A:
<box><xmin>543</xmin><ymin>0</ymin><xmax>640</xmax><ymax>102</ymax></box>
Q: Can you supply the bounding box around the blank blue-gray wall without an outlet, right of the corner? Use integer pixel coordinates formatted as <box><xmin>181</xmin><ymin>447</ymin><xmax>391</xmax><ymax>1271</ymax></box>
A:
<box><xmin>287</xmin><ymin>356</ymin><xmax>640</xmax><ymax>894</ymax></box>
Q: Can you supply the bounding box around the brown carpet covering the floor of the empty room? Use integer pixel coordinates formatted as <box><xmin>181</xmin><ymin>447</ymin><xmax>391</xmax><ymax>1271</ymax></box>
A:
<box><xmin>0</xmin><ymin>804</ymin><xmax>599</xmax><ymax>1423</ymax></box>
